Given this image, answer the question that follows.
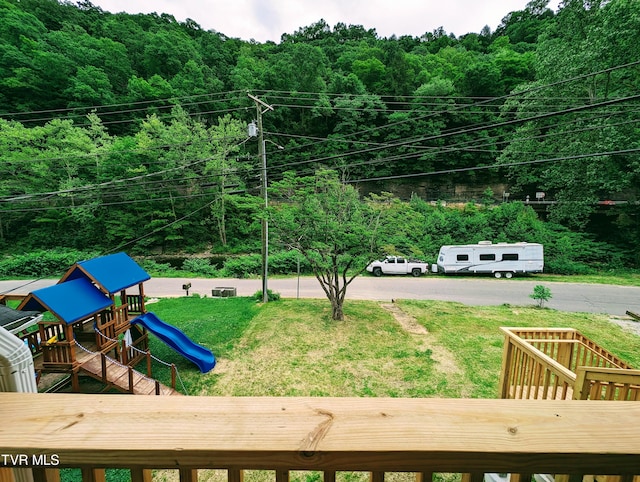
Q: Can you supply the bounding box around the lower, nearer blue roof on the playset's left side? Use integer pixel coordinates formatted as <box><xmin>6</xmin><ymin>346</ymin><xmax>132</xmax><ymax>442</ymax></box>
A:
<box><xmin>20</xmin><ymin>278</ymin><xmax>112</xmax><ymax>324</ymax></box>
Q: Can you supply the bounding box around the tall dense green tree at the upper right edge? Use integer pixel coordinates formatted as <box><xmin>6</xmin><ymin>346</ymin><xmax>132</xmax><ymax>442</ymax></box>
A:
<box><xmin>501</xmin><ymin>0</ymin><xmax>640</xmax><ymax>229</ymax></box>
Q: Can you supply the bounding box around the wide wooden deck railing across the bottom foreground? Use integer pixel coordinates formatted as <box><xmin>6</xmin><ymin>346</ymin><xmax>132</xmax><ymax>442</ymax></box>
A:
<box><xmin>0</xmin><ymin>393</ymin><xmax>640</xmax><ymax>482</ymax></box>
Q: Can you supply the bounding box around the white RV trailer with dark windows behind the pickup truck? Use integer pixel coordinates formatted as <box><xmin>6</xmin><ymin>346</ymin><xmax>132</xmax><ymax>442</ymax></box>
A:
<box><xmin>434</xmin><ymin>241</ymin><xmax>544</xmax><ymax>278</ymax></box>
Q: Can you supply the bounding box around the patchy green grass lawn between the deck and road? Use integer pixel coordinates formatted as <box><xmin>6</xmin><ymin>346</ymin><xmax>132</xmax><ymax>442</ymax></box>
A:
<box><xmin>148</xmin><ymin>297</ymin><xmax>640</xmax><ymax>398</ymax></box>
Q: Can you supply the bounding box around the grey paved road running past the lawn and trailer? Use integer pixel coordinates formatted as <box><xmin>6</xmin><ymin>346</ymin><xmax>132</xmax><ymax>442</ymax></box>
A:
<box><xmin>0</xmin><ymin>275</ymin><xmax>640</xmax><ymax>316</ymax></box>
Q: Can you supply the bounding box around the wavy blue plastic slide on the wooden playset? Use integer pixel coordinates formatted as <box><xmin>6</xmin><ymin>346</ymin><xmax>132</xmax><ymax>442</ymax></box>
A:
<box><xmin>131</xmin><ymin>312</ymin><xmax>216</xmax><ymax>373</ymax></box>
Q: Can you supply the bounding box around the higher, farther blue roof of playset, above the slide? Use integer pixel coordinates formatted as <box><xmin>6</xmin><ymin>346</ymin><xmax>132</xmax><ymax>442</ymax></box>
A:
<box><xmin>60</xmin><ymin>253</ymin><xmax>151</xmax><ymax>294</ymax></box>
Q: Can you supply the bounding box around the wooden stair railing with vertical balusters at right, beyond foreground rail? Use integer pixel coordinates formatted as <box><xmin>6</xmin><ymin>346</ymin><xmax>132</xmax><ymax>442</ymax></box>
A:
<box><xmin>500</xmin><ymin>328</ymin><xmax>640</xmax><ymax>400</ymax></box>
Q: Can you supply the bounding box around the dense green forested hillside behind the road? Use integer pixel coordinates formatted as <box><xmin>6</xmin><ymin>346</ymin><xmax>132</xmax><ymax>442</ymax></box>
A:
<box><xmin>0</xmin><ymin>0</ymin><xmax>640</xmax><ymax>267</ymax></box>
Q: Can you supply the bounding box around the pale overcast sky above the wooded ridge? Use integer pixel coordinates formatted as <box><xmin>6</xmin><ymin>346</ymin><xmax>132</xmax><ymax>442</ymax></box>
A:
<box><xmin>92</xmin><ymin>0</ymin><xmax>560</xmax><ymax>43</ymax></box>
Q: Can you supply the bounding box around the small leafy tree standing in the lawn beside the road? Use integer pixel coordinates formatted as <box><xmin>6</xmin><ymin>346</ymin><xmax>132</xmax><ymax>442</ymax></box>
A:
<box><xmin>271</xmin><ymin>170</ymin><xmax>378</xmax><ymax>320</ymax></box>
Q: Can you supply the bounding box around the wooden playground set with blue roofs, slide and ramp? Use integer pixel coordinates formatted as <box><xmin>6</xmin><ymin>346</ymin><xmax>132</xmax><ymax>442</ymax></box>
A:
<box><xmin>0</xmin><ymin>253</ymin><xmax>216</xmax><ymax>395</ymax></box>
